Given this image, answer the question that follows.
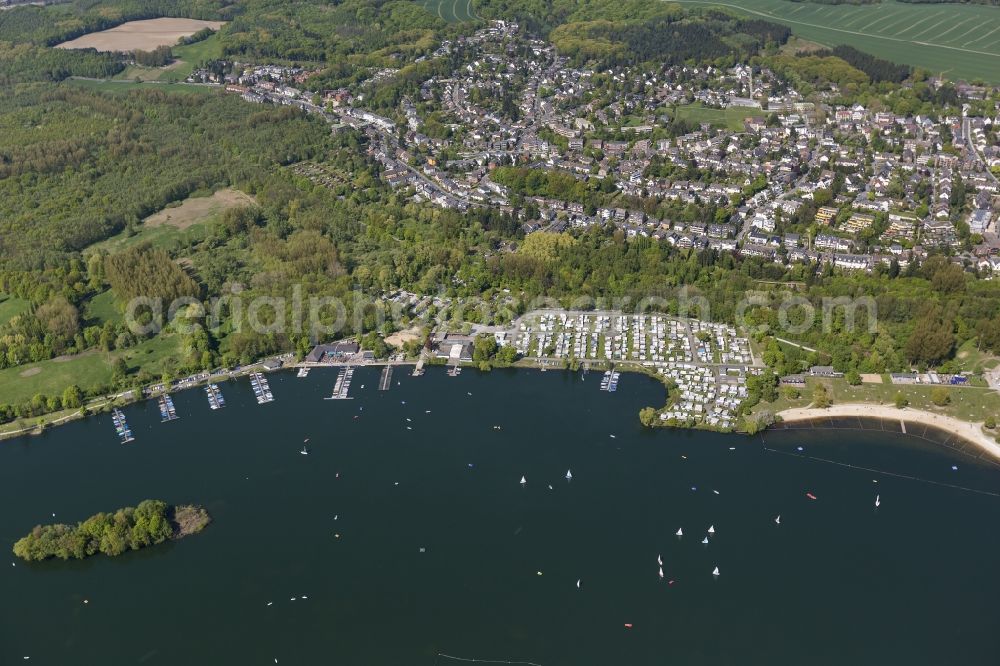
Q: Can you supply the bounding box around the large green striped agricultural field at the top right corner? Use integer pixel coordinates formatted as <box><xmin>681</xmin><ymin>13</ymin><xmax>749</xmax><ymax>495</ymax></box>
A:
<box><xmin>673</xmin><ymin>0</ymin><xmax>1000</xmax><ymax>83</ymax></box>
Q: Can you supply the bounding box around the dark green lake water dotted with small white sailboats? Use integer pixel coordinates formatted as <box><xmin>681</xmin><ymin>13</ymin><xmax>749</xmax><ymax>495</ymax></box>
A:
<box><xmin>0</xmin><ymin>368</ymin><xmax>1000</xmax><ymax>666</ymax></box>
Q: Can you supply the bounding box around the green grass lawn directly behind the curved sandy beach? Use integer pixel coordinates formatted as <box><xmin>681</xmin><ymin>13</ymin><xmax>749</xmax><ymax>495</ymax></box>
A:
<box><xmin>754</xmin><ymin>377</ymin><xmax>1000</xmax><ymax>421</ymax></box>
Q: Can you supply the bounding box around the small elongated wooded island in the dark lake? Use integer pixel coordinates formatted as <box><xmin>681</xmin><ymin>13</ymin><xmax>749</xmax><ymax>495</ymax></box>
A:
<box><xmin>14</xmin><ymin>500</ymin><xmax>211</xmax><ymax>562</ymax></box>
